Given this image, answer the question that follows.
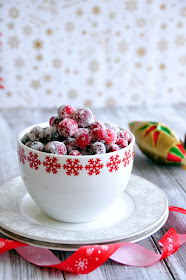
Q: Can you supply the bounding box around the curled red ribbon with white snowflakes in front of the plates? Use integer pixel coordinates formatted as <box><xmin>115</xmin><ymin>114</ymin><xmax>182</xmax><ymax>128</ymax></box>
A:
<box><xmin>0</xmin><ymin>206</ymin><xmax>186</xmax><ymax>274</ymax></box>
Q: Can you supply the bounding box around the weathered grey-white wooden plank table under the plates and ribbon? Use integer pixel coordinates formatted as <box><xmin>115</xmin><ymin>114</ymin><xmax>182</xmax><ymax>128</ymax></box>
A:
<box><xmin>0</xmin><ymin>104</ymin><xmax>186</xmax><ymax>280</ymax></box>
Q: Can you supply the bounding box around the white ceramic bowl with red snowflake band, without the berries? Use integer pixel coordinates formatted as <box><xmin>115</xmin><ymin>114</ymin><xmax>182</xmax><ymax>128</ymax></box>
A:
<box><xmin>17</xmin><ymin>123</ymin><xmax>135</xmax><ymax>223</ymax></box>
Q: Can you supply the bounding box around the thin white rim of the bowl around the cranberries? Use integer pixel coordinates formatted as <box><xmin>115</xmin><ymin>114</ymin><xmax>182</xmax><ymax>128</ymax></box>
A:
<box><xmin>17</xmin><ymin>122</ymin><xmax>135</xmax><ymax>159</ymax></box>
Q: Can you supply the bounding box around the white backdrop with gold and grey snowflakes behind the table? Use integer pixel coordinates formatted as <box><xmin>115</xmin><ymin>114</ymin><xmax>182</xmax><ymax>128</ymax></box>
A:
<box><xmin>0</xmin><ymin>0</ymin><xmax>186</xmax><ymax>107</ymax></box>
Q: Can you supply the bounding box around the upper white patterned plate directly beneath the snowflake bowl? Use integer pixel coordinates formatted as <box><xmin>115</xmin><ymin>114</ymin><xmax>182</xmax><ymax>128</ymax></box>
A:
<box><xmin>0</xmin><ymin>175</ymin><xmax>168</xmax><ymax>245</ymax></box>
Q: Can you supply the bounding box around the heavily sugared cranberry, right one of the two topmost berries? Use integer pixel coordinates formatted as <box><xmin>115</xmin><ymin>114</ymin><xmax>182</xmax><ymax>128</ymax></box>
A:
<box><xmin>72</xmin><ymin>107</ymin><xmax>95</xmax><ymax>127</ymax></box>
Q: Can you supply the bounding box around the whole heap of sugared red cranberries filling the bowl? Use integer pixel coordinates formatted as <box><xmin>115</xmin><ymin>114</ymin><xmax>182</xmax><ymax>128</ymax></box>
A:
<box><xmin>21</xmin><ymin>105</ymin><xmax>131</xmax><ymax>156</ymax></box>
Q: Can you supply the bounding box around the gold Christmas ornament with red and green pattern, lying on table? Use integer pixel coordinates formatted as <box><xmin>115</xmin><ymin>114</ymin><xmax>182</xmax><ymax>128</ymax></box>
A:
<box><xmin>129</xmin><ymin>121</ymin><xmax>186</xmax><ymax>169</ymax></box>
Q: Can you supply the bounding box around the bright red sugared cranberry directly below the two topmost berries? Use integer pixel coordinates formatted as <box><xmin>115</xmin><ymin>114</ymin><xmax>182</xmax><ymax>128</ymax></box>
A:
<box><xmin>58</xmin><ymin>118</ymin><xmax>78</xmax><ymax>137</ymax></box>
